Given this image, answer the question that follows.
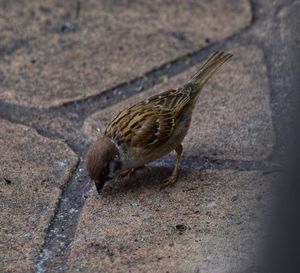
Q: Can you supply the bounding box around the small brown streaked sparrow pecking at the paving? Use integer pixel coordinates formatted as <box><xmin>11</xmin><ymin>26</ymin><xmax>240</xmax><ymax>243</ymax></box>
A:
<box><xmin>86</xmin><ymin>51</ymin><xmax>233</xmax><ymax>191</ymax></box>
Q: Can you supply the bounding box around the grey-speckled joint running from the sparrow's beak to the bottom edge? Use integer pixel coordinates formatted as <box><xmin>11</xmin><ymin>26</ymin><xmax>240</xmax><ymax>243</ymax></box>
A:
<box><xmin>34</xmin><ymin>160</ymin><xmax>91</xmax><ymax>273</ymax></box>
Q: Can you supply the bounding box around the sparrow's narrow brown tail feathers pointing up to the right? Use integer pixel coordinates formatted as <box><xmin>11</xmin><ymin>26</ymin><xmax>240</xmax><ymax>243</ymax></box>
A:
<box><xmin>187</xmin><ymin>51</ymin><xmax>233</xmax><ymax>93</ymax></box>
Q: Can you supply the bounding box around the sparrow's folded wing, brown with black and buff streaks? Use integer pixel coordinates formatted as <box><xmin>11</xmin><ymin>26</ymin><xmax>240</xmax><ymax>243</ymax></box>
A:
<box><xmin>105</xmin><ymin>90</ymin><xmax>189</xmax><ymax>149</ymax></box>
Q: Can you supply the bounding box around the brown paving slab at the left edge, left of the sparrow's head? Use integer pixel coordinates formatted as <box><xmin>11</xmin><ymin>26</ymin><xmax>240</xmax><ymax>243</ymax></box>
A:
<box><xmin>0</xmin><ymin>120</ymin><xmax>77</xmax><ymax>272</ymax></box>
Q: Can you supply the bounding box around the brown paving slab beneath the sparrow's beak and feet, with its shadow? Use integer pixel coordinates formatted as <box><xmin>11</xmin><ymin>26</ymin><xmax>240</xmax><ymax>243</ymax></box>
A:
<box><xmin>68</xmin><ymin>168</ymin><xmax>273</xmax><ymax>273</ymax></box>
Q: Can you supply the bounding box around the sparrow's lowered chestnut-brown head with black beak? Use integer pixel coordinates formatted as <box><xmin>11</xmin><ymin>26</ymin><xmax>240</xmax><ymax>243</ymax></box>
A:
<box><xmin>86</xmin><ymin>136</ymin><xmax>122</xmax><ymax>194</ymax></box>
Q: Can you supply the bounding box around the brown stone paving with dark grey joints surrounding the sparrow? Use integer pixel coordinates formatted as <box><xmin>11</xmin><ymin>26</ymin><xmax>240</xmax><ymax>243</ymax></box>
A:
<box><xmin>0</xmin><ymin>0</ymin><xmax>300</xmax><ymax>273</ymax></box>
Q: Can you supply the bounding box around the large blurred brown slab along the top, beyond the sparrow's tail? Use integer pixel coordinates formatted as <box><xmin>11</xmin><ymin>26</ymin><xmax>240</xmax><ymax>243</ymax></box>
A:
<box><xmin>0</xmin><ymin>0</ymin><xmax>252</xmax><ymax>107</ymax></box>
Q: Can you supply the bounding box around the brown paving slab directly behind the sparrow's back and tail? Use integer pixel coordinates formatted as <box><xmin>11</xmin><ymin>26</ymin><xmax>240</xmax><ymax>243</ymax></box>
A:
<box><xmin>83</xmin><ymin>45</ymin><xmax>274</xmax><ymax>160</ymax></box>
